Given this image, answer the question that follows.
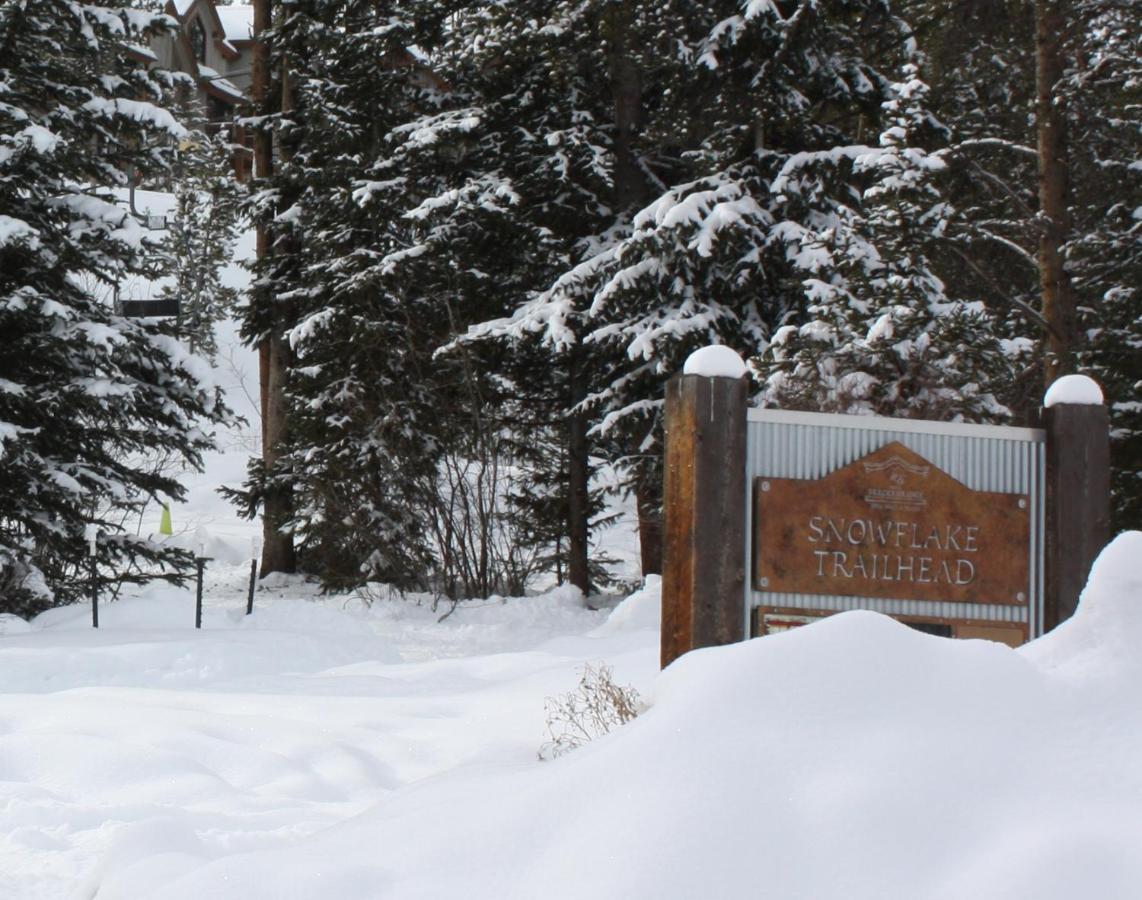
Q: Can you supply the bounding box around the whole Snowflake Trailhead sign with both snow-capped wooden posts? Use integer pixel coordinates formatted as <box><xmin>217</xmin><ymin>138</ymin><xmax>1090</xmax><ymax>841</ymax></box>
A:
<box><xmin>661</xmin><ymin>358</ymin><xmax>1110</xmax><ymax>666</ymax></box>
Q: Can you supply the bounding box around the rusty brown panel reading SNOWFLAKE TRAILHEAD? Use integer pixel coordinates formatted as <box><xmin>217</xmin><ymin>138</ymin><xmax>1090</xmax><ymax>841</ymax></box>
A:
<box><xmin>754</xmin><ymin>442</ymin><xmax>1030</xmax><ymax>604</ymax></box>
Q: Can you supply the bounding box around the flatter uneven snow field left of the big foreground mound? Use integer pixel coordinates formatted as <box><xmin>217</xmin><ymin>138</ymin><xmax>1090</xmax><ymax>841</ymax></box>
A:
<box><xmin>0</xmin><ymin>566</ymin><xmax>656</xmax><ymax>900</ymax></box>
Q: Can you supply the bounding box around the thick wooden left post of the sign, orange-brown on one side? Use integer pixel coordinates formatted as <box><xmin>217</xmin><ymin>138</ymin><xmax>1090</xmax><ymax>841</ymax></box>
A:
<box><xmin>661</xmin><ymin>365</ymin><xmax>748</xmax><ymax>668</ymax></box>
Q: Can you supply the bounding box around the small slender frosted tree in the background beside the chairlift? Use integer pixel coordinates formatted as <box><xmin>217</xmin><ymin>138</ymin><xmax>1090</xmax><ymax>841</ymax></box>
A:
<box><xmin>160</xmin><ymin>121</ymin><xmax>241</xmax><ymax>360</ymax></box>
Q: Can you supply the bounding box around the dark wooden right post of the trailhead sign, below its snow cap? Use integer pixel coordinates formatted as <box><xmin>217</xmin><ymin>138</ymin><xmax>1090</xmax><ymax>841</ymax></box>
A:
<box><xmin>1042</xmin><ymin>376</ymin><xmax>1110</xmax><ymax>630</ymax></box>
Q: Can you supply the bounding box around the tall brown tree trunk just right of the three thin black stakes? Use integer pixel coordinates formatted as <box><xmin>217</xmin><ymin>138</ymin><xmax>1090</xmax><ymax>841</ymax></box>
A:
<box><xmin>251</xmin><ymin>0</ymin><xmax>297</xmax><ymax>577</ymax></box>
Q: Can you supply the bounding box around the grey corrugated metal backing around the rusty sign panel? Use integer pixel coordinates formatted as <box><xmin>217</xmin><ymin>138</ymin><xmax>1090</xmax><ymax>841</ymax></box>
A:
<box><xmin>746</xmin><ymin>409</ymin><xmax>1046</xmax><ymax>637</ymax></box>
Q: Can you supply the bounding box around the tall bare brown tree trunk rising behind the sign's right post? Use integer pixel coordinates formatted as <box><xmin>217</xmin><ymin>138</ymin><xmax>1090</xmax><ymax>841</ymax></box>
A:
<box><xmin>1035</xmin><ymin>0</ymin><xmax>1079</xmax><ymax>385</ymax></box>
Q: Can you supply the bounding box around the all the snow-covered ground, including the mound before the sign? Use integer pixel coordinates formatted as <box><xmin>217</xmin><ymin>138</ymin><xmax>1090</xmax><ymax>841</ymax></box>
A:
<box><xmin>0</xmin><ymin>193</ymin><xmax>1142</xmax><ymax>900</ymax></box>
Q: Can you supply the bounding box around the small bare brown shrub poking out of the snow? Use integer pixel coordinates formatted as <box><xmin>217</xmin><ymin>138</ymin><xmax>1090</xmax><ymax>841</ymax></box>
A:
<box><xmin>539</xmin><ymin>662</ymin><xmax>643</xmax><ymax>760</ymax></box>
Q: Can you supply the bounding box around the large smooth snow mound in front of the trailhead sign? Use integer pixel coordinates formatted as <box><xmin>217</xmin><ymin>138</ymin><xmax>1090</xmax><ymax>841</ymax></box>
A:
<box><xmin>120</xmin><ymin>555</ymin><xmax>1142</xmax><ymax>900</ymax></box>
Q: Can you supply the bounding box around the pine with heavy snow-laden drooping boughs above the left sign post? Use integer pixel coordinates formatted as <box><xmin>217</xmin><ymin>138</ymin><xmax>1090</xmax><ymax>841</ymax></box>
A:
<box><xmin>486</xmin><ymin>0</ymin><xmax>931</xmax><ymax>555</ymax></box>
